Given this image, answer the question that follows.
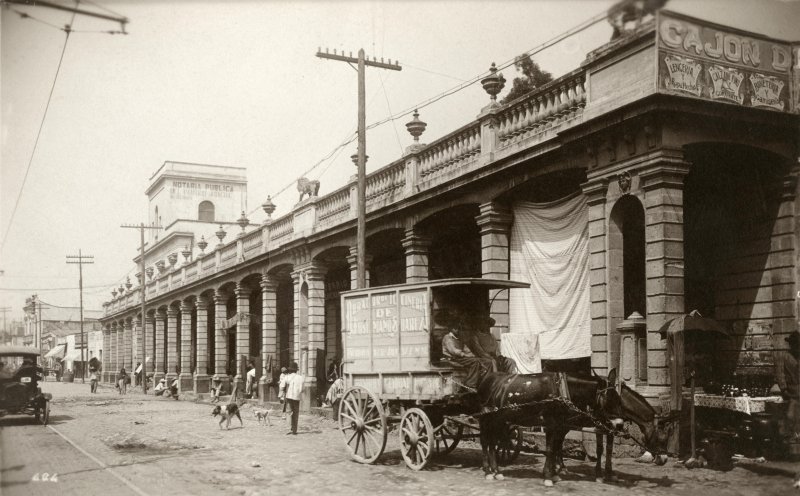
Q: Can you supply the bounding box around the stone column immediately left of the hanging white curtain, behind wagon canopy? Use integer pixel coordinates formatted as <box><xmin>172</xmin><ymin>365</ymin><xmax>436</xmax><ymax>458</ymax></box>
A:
<box><xmin>475</xmin><ymin>202</ymin><xmax>521</xmax><ymax>340</ymax></box>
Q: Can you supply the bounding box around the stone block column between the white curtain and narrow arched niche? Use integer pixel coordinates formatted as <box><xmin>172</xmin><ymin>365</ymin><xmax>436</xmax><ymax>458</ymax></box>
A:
<box><xmin>581</xmin><ymin>178</ymin><xmax>613</xmax><ymax>375</ymax></box>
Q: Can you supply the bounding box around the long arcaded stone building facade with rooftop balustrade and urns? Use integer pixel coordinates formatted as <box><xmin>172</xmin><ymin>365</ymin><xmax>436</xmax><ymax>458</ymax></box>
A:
<box><xmin>101</xmin><ymin>11</ymin><xmax>800</xmax><ymax>406</ymax></box>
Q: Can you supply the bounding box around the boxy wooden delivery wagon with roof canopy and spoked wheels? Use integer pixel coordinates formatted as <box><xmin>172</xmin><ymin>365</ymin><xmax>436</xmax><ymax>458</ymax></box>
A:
<box><xmin>339</xmin><ymin>278</ymin><xmax>528</xmax><ymax>470</ymax></box>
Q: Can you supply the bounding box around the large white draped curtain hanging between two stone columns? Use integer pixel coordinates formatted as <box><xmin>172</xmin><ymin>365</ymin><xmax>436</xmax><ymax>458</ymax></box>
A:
<box><xmin>509</xmin><ymin>194</ymin><xmax>591</xmax><ymax>360</ymax></box>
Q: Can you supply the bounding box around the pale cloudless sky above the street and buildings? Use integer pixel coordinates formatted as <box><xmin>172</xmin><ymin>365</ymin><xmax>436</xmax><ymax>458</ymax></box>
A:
<box><xmin>0</xmin><ymin>0</ymin><xmax>800</xmax><ymax>320</ymax></box>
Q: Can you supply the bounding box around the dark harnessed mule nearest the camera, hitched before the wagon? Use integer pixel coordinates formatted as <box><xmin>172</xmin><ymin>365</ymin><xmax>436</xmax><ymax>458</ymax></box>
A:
<box><xmin>476</xmin><ymin>370</ymin><xmax>622</xmax><ymax>486</ymax></box>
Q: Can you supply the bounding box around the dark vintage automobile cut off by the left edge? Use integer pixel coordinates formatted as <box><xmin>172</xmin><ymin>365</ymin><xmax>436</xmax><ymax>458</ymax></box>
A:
<box><xmin>0</xmin><ymin>346</ymin><xmax>53</xmax><ymax>425</ymax></box>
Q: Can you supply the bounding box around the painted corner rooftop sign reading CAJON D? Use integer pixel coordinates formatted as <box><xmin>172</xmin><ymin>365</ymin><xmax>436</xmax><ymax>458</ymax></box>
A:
<box><xmin>656</xmin><ymin>11</ymin><xmax>792</xmax><ymax>111</ymax></box>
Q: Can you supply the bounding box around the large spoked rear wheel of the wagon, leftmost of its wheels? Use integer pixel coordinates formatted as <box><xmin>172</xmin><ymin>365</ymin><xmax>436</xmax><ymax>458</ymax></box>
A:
<box><xmin>339</xmin><ymin>386</ymin><xmax>387</xmax><ymax>463</ymax></box>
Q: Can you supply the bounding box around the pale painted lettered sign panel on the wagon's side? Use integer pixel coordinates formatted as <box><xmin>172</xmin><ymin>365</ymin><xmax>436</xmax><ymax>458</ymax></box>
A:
<box><xmin>342</xmin><ymin>289</ymin><xmax>430</xmax><ymax>374</ymax></box>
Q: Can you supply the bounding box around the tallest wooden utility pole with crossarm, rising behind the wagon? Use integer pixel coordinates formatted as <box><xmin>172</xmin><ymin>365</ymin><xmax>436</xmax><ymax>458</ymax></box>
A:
<box><xmin>317</xmin><ymin>48</ymin><xmax>402</xmax><ymax>289</ymax></box>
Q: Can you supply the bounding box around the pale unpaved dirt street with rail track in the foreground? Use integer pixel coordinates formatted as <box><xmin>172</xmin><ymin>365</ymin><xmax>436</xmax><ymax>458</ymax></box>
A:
<box><xmin>0</xmin><ymin>382</ymin><xmax>800</xmax><ymax>496</ymax></box>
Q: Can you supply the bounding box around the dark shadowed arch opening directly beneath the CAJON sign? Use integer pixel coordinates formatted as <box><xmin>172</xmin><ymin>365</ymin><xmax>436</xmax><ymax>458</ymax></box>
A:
<box><xmin>683</xmin><ymin>142</ymin><xmax>797</xmax><ymax>376</ymax></box>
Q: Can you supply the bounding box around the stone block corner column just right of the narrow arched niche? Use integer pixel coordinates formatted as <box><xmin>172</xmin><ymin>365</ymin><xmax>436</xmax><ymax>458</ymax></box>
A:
<box><xmin>639</xmin><ymin>161</ymin><xmax>689</xmax><ymax>394</ymax></box>
